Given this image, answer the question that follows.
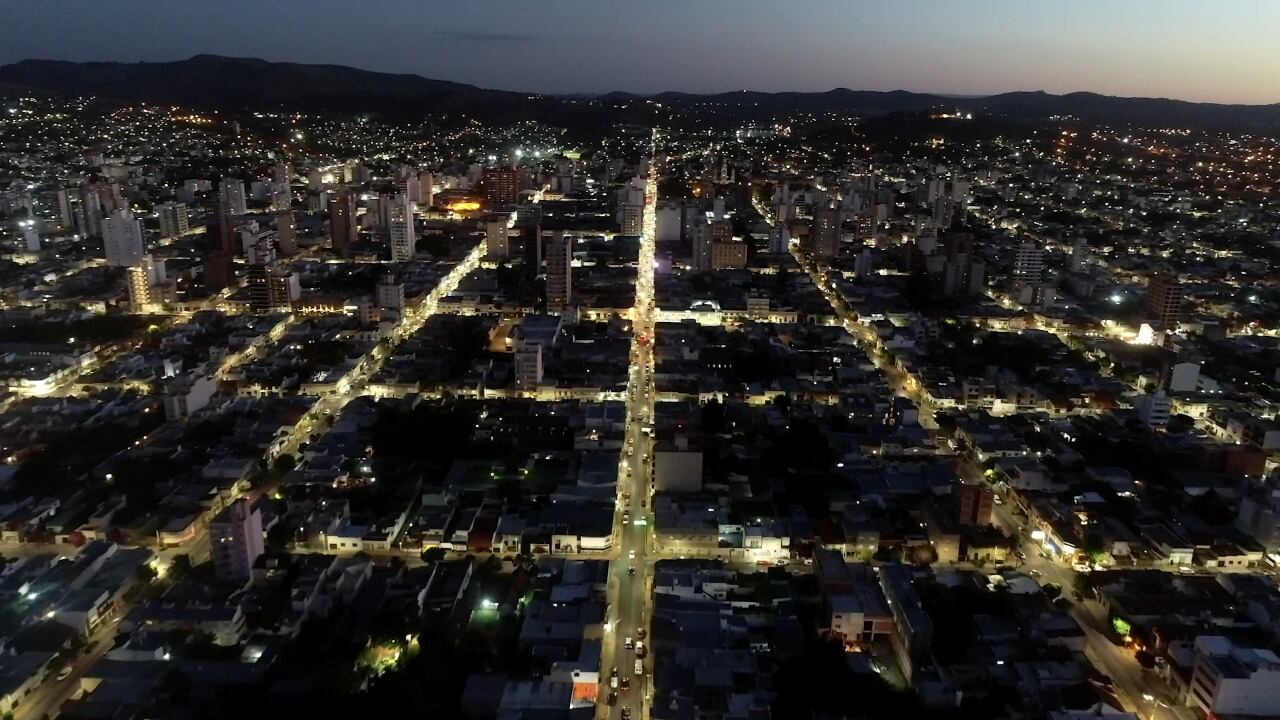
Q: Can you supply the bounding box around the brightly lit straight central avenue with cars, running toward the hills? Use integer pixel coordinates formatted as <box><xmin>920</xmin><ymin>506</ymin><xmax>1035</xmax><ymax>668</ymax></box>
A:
<box><xmin>598</xmin><ymin>135</ymin><xmax>658</xmax><ymax>719</ymax></box>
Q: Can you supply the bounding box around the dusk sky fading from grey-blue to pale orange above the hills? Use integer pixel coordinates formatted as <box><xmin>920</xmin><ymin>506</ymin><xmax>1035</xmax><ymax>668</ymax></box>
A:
<box><xmin>0</xmin><ymin>0</ymin><xmax>1280</xmax><ymax>104</ymax></box>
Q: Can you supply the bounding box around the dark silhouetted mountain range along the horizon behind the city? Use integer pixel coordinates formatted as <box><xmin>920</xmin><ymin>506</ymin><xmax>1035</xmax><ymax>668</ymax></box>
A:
<box><xmin>0</xmin><ymin>55</ymin><xmax>1280</xmax><ymax>133</ymax></box>
